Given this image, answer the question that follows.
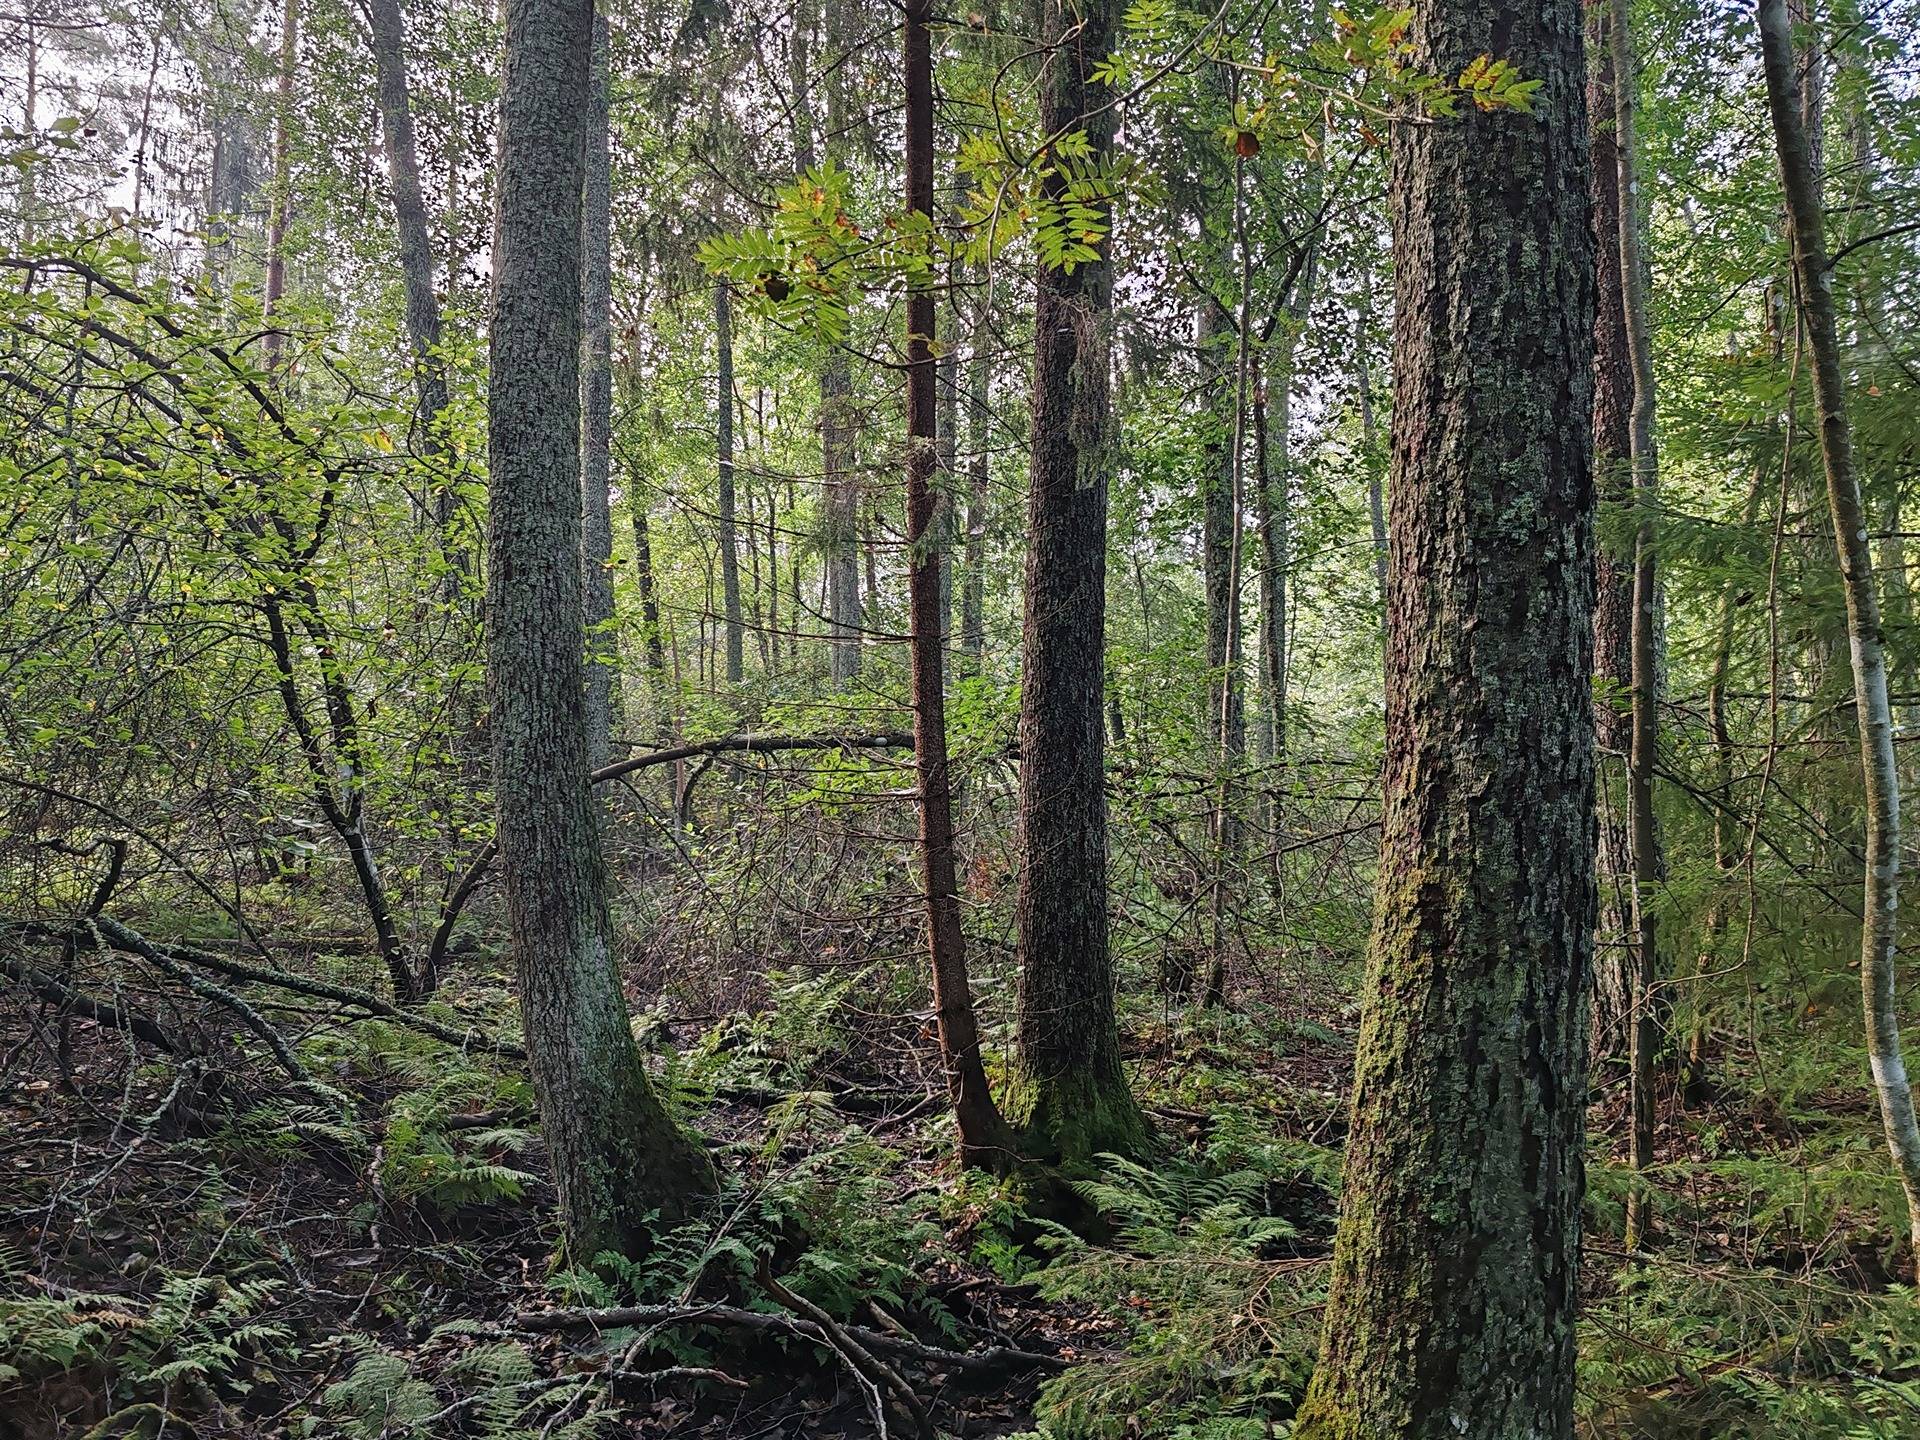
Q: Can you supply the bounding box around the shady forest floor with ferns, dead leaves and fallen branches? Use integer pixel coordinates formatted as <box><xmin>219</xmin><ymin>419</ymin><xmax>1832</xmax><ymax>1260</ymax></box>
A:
<box><xmin>0</xmin><ymin>917</ymin><xmax>1920</xmax><ymax>1440</ymax></box>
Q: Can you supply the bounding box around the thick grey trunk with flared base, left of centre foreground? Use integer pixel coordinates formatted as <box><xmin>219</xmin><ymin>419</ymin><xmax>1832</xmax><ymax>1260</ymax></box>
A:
<box><xmin>486</xmin><ymin>0</ymin><xmax>712</xmax><ymax>1261</ymax></box>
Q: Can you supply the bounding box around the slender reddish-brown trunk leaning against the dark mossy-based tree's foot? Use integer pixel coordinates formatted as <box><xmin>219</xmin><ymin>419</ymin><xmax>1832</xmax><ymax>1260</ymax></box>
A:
<box><xmin>902</xmin><ymin>0</ymin><xmax>1013</xmax><ymax>1169</ymax></box>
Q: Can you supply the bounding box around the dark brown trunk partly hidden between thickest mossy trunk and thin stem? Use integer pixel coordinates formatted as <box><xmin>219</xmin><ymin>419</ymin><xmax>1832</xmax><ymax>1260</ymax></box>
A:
<box><xmin>1586</xmin><ymin>4</ymin><xmax>1634</xmax><ymax>1064</ymax></box>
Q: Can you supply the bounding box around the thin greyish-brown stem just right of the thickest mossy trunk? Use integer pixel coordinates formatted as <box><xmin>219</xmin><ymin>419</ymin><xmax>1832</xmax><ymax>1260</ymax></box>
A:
<box><xmin>1607</xmin><ymin>0</ymin><xmax>1661</xmax><ymax>1250</ymax></box>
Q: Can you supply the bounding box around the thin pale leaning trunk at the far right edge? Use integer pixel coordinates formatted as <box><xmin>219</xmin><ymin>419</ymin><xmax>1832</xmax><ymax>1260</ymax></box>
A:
<box><xmin>1757</xmin><ymin>0</ymin><xmax>1920</xmax><ymax>1263</ymax></box>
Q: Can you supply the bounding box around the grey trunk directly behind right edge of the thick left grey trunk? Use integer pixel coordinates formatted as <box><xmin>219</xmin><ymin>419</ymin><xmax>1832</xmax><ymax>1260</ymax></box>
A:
<box><xmin>580</xmin><ymin>12</ymin><xmax>620</xmax><ymax>770</ymax></box>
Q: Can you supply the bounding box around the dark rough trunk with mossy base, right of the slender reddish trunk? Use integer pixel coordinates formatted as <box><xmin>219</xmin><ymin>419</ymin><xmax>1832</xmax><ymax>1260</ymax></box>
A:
<box><xmin>1014</xmin><ymin>0</ymin><xmax>1146</xmax><ymax>1165</ymax></box>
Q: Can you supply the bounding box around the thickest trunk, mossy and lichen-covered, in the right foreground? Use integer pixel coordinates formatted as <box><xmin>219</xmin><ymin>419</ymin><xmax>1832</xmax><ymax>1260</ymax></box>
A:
<box><xmin>1294</xmin><ymin>0</ymin><xmax>1596</xmax><ymax>1440</ymax></box>
